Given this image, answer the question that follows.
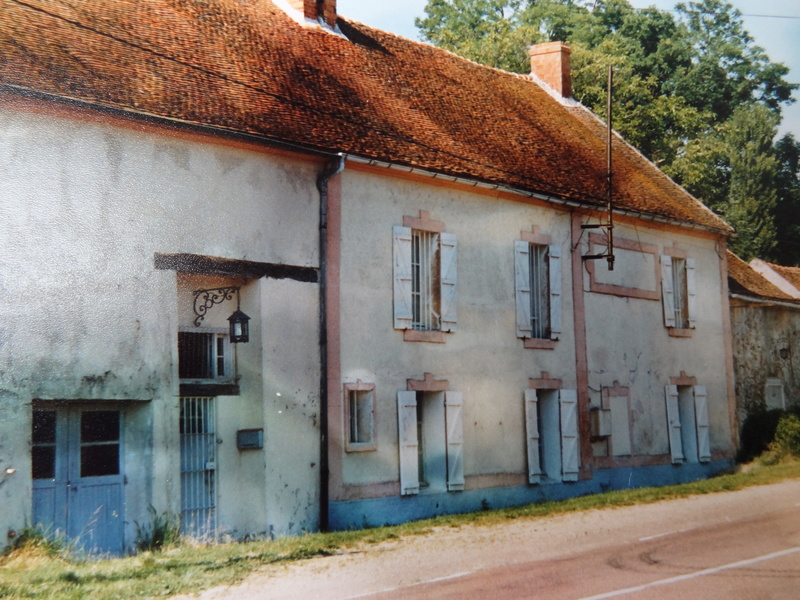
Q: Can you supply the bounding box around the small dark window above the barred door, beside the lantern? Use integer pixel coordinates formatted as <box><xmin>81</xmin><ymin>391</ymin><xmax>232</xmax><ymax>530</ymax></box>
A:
<box><xmin>178</xmin><ymin>330</ymin><xmax>233</xmax><ymax>380</ymax></box>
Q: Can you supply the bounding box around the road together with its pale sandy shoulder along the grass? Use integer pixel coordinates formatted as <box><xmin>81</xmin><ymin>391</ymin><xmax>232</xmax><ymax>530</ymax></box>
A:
<box><xmin>184</xmin><ymin>481</ymin><xmax>800</xmax><ymax>600</ymax></box>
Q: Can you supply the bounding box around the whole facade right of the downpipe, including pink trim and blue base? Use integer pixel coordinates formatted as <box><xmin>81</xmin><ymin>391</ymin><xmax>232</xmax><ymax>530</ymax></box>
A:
<box><xmin>329</xmin><ymin>163</ymin><xmax>735</xmax><ymax>527</ymax></box>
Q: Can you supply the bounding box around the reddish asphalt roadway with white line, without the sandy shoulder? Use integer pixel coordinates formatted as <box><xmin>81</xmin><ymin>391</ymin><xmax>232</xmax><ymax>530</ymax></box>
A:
<box><xmin>359</xmin><ymin>498</ymin><xmax>800</xmax><ymax>600</ymax></box>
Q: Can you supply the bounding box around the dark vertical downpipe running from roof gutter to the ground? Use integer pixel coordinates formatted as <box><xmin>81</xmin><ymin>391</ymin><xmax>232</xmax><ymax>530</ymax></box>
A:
<box><xmin>317</xmin><ymin>153</ymin><xmax>345</xmax><ymax>531</ymax></box>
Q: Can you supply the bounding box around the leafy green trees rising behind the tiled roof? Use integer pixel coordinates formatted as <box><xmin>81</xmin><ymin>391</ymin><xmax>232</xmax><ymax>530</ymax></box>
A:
<box><xmin>416</xmin><ymin>0</ymin><xmax>800</xmax><ymax>264</ymax></box>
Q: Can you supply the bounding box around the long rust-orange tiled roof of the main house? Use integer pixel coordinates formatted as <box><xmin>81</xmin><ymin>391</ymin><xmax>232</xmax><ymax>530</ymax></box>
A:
<box><xmin>0</xmin><ymin>0</ymin><xmax>730</xmax><ymax>232</ymax></box>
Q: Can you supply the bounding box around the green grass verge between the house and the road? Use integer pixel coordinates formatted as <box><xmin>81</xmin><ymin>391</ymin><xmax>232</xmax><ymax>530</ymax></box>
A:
<box><xmin>0</xmin><ymin>461</ymin><xmax>800</xmax><ymax>600</ymax></box>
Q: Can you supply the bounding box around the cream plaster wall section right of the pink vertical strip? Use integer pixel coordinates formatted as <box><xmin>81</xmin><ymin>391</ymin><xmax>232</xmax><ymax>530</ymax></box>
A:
<box><xmin>583</xmin><ymin>224</ymin><xmax>732</xmax><ymax>456</ymax></box>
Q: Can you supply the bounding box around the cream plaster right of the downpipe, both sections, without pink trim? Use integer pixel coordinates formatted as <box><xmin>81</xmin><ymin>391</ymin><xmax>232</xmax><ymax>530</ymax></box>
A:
<box><xmin>332</xmin><ymin>168</ymin><xmax>733</xmax><ymax>500</ymax></box>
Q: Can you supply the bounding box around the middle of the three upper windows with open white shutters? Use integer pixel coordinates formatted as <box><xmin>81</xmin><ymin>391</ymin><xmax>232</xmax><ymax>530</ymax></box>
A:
<box><xmin>514</xmin><ymin>240</ymin><xmax>561</xmax><ymax>347</ymax></box>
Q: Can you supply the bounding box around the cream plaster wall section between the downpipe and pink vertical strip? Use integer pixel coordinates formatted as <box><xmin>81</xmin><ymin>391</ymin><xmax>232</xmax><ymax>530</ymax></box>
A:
<box><xmin>339</xmin><ymin>170</ymin><xmax>576</xmax><ymax>486</ymax></box>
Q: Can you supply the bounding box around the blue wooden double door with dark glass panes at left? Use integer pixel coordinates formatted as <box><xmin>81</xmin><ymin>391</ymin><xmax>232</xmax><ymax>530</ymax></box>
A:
<box><xmin>31</xmin><ymin>407</ymin><xmax>124</xmax><ymax>554</ymax></box>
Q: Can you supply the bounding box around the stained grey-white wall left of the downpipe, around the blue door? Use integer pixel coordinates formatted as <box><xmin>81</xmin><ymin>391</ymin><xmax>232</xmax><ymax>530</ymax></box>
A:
<box><xmin>0</xmin><ymin>101</ymin><xmax>319</xmax><ymax>545</ymax></box>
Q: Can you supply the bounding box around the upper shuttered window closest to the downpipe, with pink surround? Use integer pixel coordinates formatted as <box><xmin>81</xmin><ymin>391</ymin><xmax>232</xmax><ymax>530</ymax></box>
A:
<box><xmin>393</xmin><ymin>212</ymin><xmax>456</xmax><ymax>342</ymax></box>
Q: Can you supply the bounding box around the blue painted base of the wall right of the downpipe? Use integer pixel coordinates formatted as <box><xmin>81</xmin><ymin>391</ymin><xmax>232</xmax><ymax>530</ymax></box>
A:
<box><xmin>329</xmin><ymin>460</ymin><xmax>733</xmax><ymax>530</ymax></box>
